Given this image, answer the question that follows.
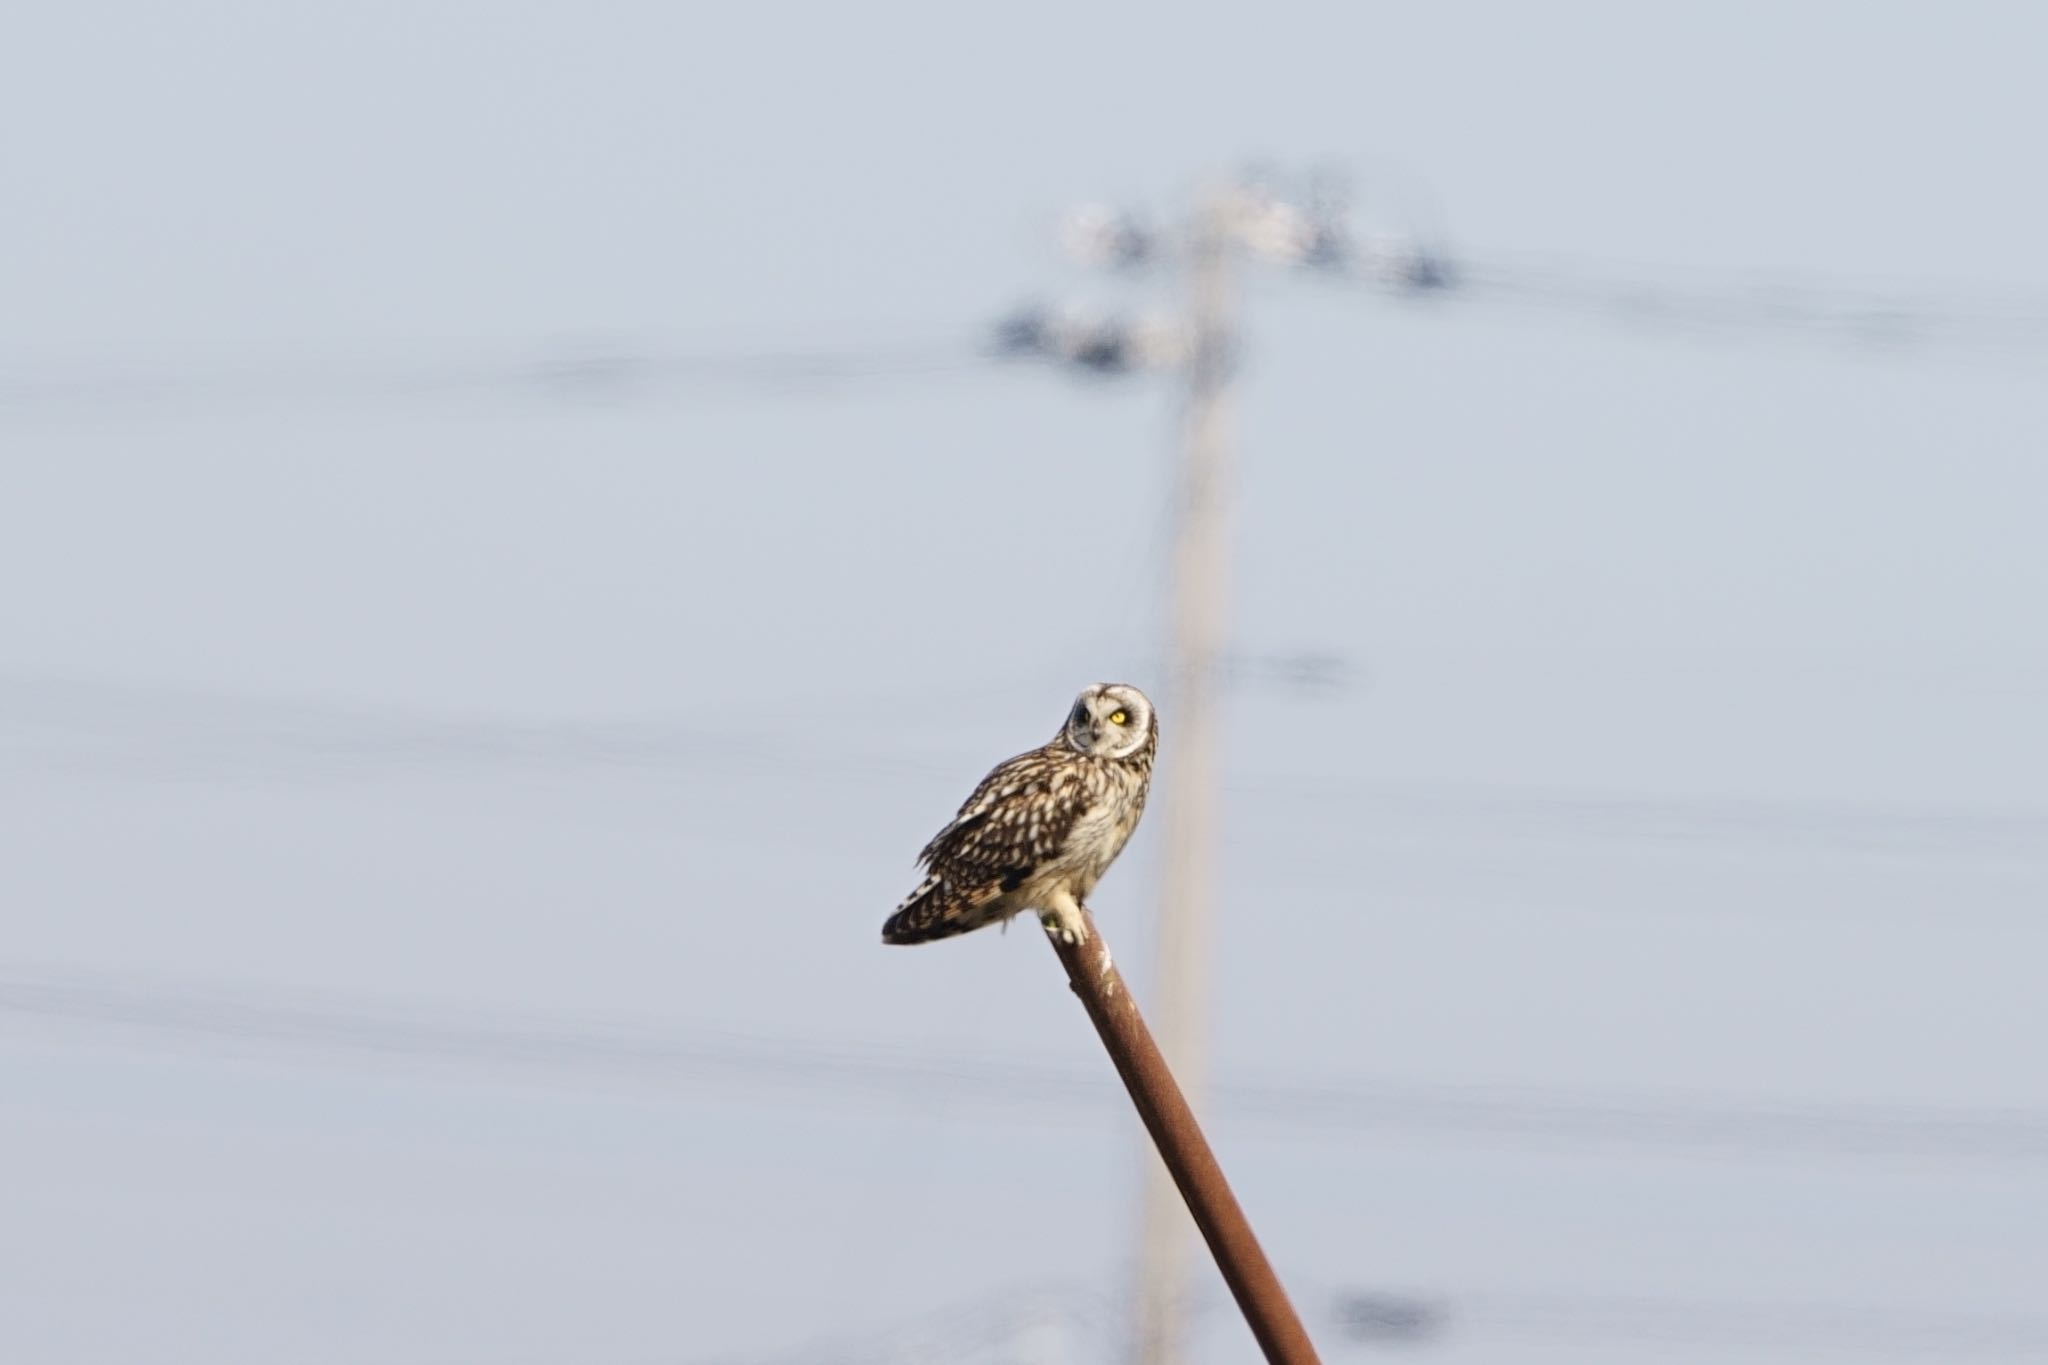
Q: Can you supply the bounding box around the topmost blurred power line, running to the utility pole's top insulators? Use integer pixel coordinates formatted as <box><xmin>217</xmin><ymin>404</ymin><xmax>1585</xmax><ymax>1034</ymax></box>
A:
<box><xmin>12</xmin><ymin>241</ymin><xmax>2048</xmax><ymax>417</ymax></box>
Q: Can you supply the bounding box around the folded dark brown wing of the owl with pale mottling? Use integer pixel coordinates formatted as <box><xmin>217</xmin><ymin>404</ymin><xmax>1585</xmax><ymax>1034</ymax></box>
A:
<box><xmin>918</xmin><ymin>749</ymin><xmax>1090</xmax><ymax>890</ymax></box>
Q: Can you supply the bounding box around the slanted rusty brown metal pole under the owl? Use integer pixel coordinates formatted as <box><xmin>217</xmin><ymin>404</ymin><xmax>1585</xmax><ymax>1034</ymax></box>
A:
<box><xmin>1047</xmin><ymin>911</ymin><xmax>1321</xmax><ymax>1365</ymax></box>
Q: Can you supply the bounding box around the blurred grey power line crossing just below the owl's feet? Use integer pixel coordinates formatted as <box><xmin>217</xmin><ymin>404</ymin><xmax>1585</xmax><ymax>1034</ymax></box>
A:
<box><xmin>12</xmin><ymin>950</ymin><xmax>2048</xmax><ymax>1164</ymax></box>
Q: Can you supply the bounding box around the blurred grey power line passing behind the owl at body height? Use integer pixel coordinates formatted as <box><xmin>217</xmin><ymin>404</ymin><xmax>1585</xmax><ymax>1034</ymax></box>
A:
<box><xmin>0</xmin><ymin>675</ymin><xmax>2048</xmax><ymax>872</ymax></box>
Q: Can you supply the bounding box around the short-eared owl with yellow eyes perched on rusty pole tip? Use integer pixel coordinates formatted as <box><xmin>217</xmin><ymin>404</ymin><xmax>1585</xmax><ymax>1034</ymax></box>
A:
<box><xmin>883</xmin><ymin>684</ymin><xmax>1159</xmax><ymax>943</ymax></box>
